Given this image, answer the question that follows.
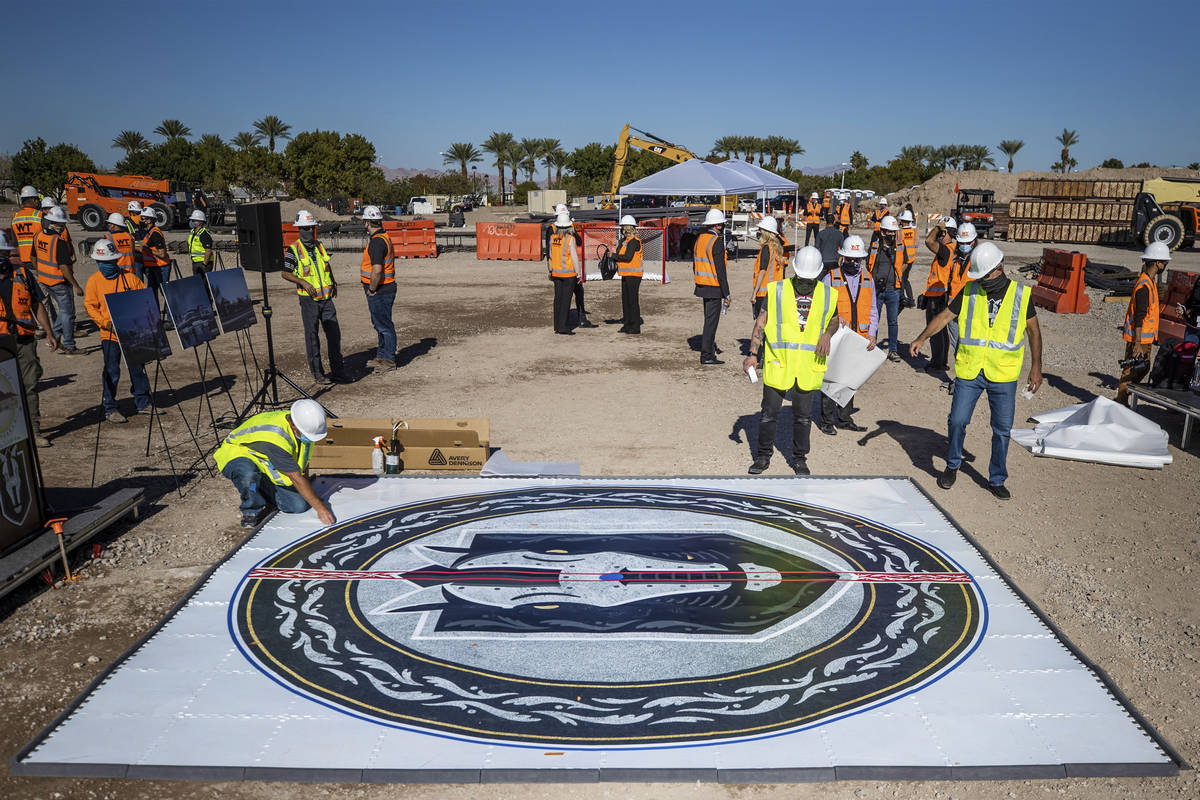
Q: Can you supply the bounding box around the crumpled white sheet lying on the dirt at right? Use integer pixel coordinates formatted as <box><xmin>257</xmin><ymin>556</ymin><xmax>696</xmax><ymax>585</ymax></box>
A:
<box><xmin>1012</xmin><ymin>397</ymin><xmax>1171</xmax><ymax>469</ymax></box>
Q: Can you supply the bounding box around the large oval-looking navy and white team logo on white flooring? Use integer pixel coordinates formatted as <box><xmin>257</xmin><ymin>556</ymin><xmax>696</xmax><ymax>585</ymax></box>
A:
<box><xmin>230</xmin><ymin>486</ymin><xmax>985</xmax><ymax>747</ymax></box>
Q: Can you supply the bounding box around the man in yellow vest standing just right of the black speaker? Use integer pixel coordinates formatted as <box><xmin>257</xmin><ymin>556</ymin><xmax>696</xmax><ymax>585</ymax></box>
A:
<box><xmin>282</xmin><ymin>209</ymin><xmax>346</xmax><ymax>386</ymax></box>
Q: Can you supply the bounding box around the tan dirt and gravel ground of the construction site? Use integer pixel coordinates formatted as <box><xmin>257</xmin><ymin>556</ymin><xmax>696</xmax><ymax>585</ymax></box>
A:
<box><xmin>0</xmin><ymin>210</ymin><xmax>1200</xmax><ymax>800</ymax></box>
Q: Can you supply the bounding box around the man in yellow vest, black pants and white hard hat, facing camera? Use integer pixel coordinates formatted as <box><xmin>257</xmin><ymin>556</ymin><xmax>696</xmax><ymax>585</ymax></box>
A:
<box><xmin>742</xmin><ymin>247</ymin><xmax>840</xmax><ymax>475</ymax></box>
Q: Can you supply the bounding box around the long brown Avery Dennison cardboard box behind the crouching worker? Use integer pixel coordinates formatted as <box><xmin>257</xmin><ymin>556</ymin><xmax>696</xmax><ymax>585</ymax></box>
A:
<box><xmin>310</xmin><ymin>417</ymin><xmax>491</xmax><ymax>473</ymax></box>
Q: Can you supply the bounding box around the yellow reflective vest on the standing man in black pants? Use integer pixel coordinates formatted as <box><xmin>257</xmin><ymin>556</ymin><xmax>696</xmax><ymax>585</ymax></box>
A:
<box><xmin>762</xmin><ymin>278</ymin><xmax>838</xmax><ymax>391</ymax></box>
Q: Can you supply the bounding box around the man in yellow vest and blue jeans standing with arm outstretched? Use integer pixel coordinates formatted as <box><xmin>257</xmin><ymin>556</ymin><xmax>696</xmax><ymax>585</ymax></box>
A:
<box><xmin>908</xmin><ymin>242</ymin><xmax>1042</xmax><ymax>500</ymax></box>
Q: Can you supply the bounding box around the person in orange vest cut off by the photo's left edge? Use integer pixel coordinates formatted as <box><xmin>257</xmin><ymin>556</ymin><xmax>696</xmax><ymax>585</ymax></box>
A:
<box><xmin>0</xmin><ymin>230</ymin><xmax>59</xmax><ymax>447</ymax></box>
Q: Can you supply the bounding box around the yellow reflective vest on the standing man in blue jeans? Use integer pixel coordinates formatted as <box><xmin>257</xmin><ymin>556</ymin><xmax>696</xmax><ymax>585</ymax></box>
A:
<box><xmin>954</xmin><ymin>281</ymin><xmax>1033</xmax><ymax>384</ymax></box>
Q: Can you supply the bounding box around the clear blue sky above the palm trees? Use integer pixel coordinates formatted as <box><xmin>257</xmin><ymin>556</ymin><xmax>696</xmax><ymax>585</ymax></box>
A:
<box><xmin>7</xmin><ymin>0</ymin><xmax>1200</xmax><ymax>175</ymax></box>
